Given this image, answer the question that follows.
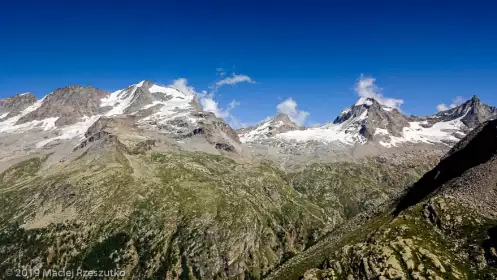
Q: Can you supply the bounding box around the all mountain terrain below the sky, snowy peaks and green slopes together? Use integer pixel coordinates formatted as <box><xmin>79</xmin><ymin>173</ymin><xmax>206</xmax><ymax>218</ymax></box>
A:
<box><xmin>0</xmin><ymin>81</ymin><xmax>497</xmax><ymax>280</ymax></box>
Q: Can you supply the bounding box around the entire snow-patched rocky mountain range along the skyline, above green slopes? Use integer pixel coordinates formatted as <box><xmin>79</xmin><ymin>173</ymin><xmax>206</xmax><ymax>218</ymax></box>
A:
<box><xmin>0</xmin><ymin>81</ymin><xmax>497</xmax><ymax>168</ymax></box>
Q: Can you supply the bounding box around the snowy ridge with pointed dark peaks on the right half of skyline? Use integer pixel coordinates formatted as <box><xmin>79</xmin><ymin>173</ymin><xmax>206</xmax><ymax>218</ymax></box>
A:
<box><xmin>240</xmin><ymin>96</ymin><xmax>497</xmax><ymax>148</ymax></box>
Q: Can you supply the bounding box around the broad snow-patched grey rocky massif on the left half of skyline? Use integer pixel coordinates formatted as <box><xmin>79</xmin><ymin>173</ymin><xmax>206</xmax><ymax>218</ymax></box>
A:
<box><xmin>0</xmin><ymin>81</ymin><xmax>241</xmax><ymax>167</ymax></box>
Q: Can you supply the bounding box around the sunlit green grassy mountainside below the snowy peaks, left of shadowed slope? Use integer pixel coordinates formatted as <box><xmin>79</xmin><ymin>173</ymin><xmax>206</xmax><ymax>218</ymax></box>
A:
<box><xmin>0</xmin><ymin>149</ymin><xmax>436</xmax><ymax>279</ymax></box>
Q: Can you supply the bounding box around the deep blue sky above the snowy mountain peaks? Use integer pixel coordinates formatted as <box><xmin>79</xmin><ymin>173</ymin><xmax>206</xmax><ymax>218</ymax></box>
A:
<box><xmin>0</xmin><ymin>0</ymin><xmax>497</xmax><ymax>125</ymax></box>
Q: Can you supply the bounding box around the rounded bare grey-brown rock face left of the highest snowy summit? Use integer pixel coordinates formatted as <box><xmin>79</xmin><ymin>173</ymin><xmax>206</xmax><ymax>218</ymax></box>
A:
<box><xmin>17</xmin><ymin>85</ymin><xmax>107</xmax><ymax>126</ymax></box>
